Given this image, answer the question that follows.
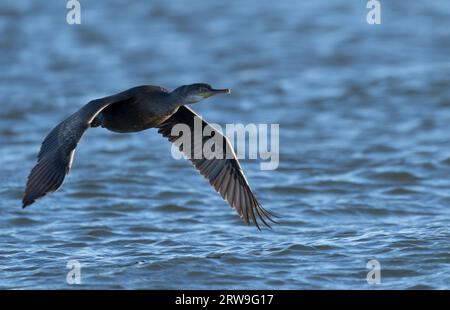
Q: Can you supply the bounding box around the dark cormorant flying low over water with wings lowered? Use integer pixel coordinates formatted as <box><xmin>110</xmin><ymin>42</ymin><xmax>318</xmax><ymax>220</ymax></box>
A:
<box><xmin>23</xmin><ymin>84</ymin><xmax>274</xmax><ymax>228</ymax></box>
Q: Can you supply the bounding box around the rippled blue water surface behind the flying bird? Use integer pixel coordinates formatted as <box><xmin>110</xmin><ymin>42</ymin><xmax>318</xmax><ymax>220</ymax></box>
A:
<box><xmin>0</xmin><ymin>0</ymin><xmax>450</xmax><ymax>289</ymax></box>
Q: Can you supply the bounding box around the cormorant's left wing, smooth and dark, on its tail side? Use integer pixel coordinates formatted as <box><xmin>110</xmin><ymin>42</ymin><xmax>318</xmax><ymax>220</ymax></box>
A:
<box><xmin>22</xmin><ymin>92</ymin><xmax>128</xmax><ymax>208</ymax></box>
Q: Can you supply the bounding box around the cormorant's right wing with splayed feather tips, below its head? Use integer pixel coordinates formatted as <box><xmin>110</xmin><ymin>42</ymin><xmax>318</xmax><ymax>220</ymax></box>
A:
<box><xmin>158</xmin><ymin>106</ymin><xmax>275</xmax><ymax>229</ymax></box>
